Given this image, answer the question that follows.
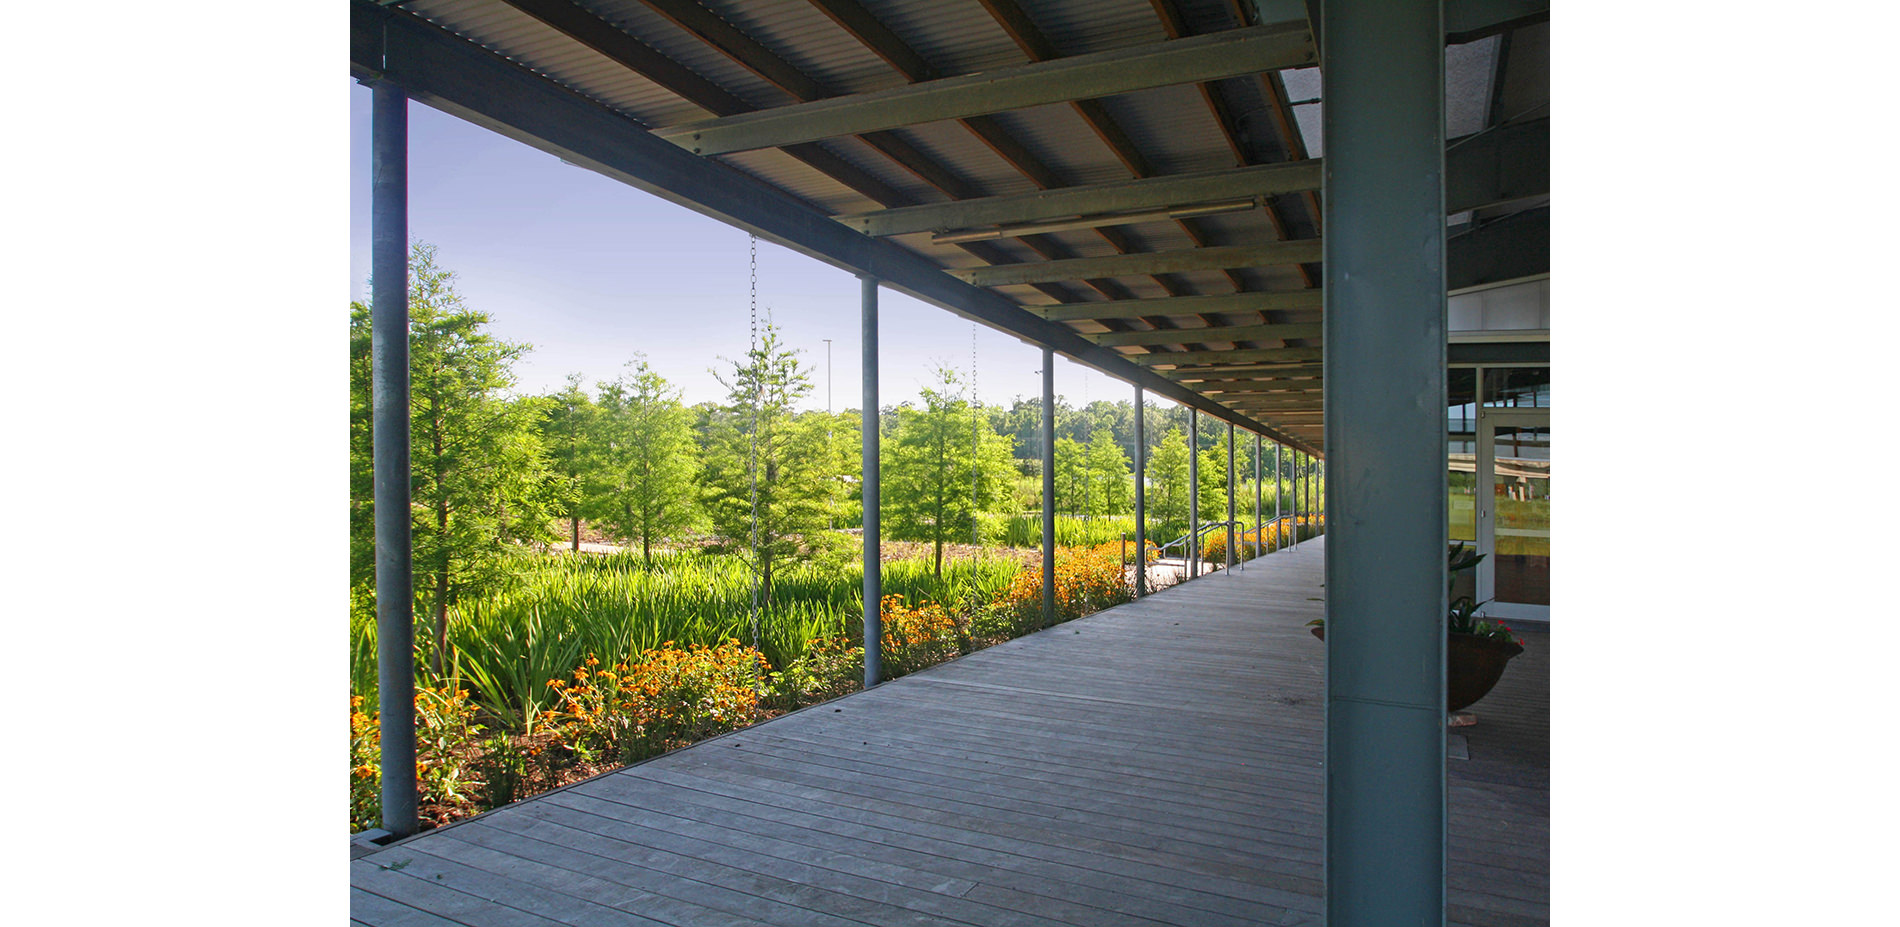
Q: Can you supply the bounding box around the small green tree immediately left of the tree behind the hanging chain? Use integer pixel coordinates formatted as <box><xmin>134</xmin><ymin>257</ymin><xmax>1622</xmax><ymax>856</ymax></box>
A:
<box><xmin>591</xmin><ymin>361</ymin><xmax>699</xmax><ymax>564</ymax></box>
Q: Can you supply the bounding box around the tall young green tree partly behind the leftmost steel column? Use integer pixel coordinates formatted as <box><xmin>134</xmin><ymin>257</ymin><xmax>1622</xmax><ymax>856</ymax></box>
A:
<box><xmin>350</xmin><ymin>243</ymin><xmax>551</xmax><ymax>674</ymax></box>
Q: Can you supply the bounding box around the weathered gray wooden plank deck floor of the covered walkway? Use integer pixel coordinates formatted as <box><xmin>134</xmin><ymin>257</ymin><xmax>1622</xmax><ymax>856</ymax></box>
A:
<box><xmin>352</xmin><ymin>541</ymin><xmax>1549</xmax><ymax>927</ymax></box>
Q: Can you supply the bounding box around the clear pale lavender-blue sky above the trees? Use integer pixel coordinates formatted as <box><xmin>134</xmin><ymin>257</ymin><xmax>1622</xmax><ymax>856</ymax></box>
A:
<box><xmin>338</xmin><ymin>82</ymin><xmax>1140</xmax><ymax>408</ymax></box>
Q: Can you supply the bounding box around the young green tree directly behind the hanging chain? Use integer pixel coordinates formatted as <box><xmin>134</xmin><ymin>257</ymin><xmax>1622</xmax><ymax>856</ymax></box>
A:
<box><xmin>705</xmin><ymin>321</ymin><xmax>830</xmax><ymax>614</ymax></box>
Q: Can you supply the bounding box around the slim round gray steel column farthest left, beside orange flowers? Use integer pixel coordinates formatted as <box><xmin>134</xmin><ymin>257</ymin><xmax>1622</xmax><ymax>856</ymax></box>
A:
<box><xmin>369</xmin><ymin>84</ymin><xmax>416</xmax><ymax>836</ymax></box>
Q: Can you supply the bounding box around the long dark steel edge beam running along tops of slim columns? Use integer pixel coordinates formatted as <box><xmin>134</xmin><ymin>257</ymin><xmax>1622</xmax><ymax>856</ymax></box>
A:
<box><xmin>350</xmin><ymin>0</ymin><xmax>1317</xmax><ymax>452</ymax></box>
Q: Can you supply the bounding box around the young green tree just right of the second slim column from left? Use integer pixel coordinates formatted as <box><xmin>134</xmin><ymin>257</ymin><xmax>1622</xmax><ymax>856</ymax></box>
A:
<box><xmin>884</xmin><ymin>367</ymin><xmax>1013</xmax><ymax>577</ymax></box>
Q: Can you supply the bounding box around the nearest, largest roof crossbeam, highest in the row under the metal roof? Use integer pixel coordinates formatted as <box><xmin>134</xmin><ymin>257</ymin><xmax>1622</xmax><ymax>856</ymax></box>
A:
<box><xmin>654</xmin><ymin>23</ymin><xmax>1315</xmax><ymax>154</ymax></box>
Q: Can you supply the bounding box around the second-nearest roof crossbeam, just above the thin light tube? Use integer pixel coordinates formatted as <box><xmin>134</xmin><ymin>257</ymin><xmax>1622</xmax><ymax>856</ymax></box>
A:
<box><xmin>836</xmin><ymin>160</ymin><xmax>1321</xmax><ymax>236</ymax></box>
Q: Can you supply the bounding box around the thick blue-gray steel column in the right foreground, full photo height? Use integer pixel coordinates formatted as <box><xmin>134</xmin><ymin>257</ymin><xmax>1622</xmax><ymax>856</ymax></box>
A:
<box><xmin>1321</xmin><ymin>0</ymin><xmax>1446</xmax><ymax>927</ymax></box>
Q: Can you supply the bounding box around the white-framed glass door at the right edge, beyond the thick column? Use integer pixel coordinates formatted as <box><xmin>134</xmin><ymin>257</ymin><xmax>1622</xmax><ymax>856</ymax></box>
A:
<box><xmin>1474</xmin><ymin>408</ymin><xmax>1550</xmax><ymax>621</ymax></box>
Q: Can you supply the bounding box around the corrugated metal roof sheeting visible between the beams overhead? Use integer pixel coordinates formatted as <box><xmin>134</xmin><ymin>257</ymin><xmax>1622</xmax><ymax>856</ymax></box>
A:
<box><xmin>357</xmin><ymin>0</ymin><xmax>1549</xmax><ymax>448</ymax></box>
